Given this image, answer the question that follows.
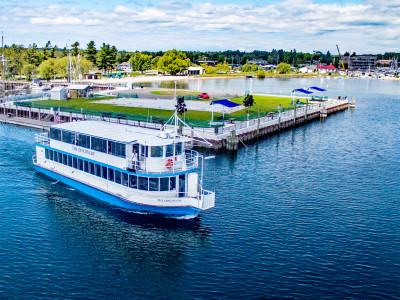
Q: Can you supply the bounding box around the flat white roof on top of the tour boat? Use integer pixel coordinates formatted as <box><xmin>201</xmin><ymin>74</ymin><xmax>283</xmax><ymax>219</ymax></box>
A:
<box><xmin>51</xmin><ymin>121</ymin><xmax>190</xmax><ymax>146</ymax></box>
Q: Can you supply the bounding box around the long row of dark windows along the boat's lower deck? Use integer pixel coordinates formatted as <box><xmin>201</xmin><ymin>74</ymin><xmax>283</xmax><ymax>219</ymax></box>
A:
<box><xmin>45</xmin><ymin>149</ymin><xmax>180</xmax><ymax>191</ymax></box>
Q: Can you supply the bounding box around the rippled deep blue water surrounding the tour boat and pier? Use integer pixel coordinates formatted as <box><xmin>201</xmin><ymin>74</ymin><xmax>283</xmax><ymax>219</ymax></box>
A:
<box><xmin>0</xmin><ymin>79</ymin><xmax>400</xmax><ymax>299</ymax></box>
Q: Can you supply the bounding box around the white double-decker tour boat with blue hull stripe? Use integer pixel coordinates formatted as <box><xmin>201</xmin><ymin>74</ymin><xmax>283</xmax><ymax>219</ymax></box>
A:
<box><xmin>33</xmin><ymin>121</ymin><xmax>215</xmax><ymax>216</ymax></box>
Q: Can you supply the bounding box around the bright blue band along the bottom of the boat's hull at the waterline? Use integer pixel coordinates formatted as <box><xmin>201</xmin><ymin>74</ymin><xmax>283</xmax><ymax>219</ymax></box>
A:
<box><xmin>34</xmin><ymin>165</ymin><xmax>200</xmax><ymax>217</ymax></box>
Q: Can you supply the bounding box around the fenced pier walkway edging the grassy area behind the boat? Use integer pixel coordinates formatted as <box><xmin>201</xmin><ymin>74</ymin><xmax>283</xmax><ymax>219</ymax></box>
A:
<box><xmin>0</xmin><ymin>99</ymin><xmax>349</xmax><ymax>150</ymax></box>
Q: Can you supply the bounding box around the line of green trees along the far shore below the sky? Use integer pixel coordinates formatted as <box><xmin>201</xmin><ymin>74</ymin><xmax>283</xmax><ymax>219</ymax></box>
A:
<box><xmin>4</xmin><ymin>41</ymin><xmax>400</xmax><ymax>80</ymax></box>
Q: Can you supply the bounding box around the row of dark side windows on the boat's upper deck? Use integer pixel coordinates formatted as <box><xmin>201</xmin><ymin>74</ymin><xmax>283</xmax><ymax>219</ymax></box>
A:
<box><xmin>50</xmin><ymin>128</ymin><xmax>126</xmax><ymax>157</ymax></box>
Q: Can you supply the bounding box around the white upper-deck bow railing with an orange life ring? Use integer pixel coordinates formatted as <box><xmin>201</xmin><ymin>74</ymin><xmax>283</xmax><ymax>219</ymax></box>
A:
<box><xmin>128</xmin><ymin>150</ymin><xmax>199</xmax><ymax>174</ymax></box>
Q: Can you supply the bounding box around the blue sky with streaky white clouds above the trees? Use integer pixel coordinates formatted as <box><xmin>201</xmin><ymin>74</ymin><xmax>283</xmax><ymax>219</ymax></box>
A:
<box><xmin>0</xmin><ymin>0</ymin><xmax>400</xmax><ymax>54</ymax></box>
